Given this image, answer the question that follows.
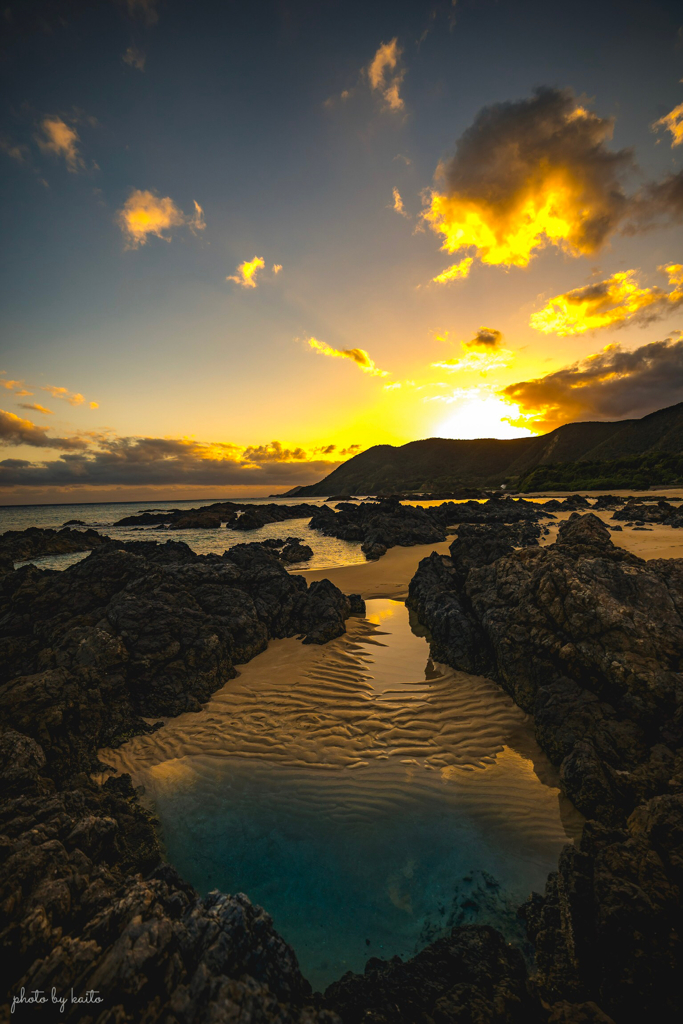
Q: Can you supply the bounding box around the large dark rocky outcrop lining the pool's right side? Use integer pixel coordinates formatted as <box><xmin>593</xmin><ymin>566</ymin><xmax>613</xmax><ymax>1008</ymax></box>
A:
<box><xmin>409</xmin><ymin>514</ymin><xmax>683</xmax><ymax>1024</ymax></box>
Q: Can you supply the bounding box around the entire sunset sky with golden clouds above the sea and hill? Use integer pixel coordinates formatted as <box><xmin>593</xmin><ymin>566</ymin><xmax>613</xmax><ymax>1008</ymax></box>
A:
<box><xmin>0</xmin><ymin>0</ymin><xmax>683</xmax><ymax>505</ymax></box>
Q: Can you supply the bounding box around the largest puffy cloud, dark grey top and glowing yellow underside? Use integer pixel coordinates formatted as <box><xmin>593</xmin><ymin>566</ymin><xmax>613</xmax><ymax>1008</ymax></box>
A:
<box><xmin>423</xmin><ymin>88</ymin><xmax>634</xmax><ymax>276</ymax></box>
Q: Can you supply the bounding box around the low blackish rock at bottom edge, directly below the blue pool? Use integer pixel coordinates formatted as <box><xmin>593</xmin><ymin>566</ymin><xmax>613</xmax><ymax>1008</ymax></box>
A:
<box><xmin>325</xmin><ymin>925</ymin><xmax>546</xmax><ymax>1024</ymax></box>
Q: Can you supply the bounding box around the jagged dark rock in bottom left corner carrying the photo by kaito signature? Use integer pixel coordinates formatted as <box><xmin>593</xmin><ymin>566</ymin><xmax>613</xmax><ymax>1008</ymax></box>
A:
<box><xmin>0</xmin><ymin>731</ymin><xmax>338</xmax><ymax>1024</ymax></box>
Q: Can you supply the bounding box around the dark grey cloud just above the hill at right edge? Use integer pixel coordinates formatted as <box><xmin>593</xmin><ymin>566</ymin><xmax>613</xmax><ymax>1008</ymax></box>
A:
<box><xmin>500</xmin><ymin>331</ymin><xmax>683</xmax><ymax>431</ymax></box>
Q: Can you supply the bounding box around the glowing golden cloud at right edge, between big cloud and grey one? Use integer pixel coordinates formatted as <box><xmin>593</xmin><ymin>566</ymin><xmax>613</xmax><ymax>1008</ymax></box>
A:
<box><xmin>529</xmin><ymin>263</ymin><xmax>683</xmax><ymax>337</ymax></box>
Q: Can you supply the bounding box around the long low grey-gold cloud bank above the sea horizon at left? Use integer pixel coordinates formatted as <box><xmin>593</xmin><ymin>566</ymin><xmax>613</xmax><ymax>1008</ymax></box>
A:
<box><xmin>0</xmin><ymin>434</ymin><xmax>350</xmax><ymax>487</ymax></box>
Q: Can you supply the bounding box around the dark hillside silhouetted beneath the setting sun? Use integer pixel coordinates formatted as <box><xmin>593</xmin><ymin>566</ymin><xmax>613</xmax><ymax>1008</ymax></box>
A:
<box><xmin>297</xmin><ymin>402</ymin><xmax>683</xmax><ymax>498</ymax></box>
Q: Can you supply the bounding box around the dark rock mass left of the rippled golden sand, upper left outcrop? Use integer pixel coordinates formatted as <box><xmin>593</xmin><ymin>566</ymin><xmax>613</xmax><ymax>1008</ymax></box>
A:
<box><xmin>0</xmin><ymin>542</ymin><xmax>360</xmax><ymax>776</ymax></box>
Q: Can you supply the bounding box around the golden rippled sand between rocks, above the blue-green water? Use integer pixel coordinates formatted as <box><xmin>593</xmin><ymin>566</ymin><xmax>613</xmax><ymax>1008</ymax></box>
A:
<box><xmin>100</xmin><ymin>600</ymin><xmax>565</xmax><ymax>777</ymax></box>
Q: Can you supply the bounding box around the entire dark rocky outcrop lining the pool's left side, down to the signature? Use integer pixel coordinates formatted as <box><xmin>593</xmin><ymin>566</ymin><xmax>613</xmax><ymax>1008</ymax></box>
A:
<box><xmin>0</xmin><ymin>542</ymin><xmax>364</xmax><ymax>1024</ymax></box>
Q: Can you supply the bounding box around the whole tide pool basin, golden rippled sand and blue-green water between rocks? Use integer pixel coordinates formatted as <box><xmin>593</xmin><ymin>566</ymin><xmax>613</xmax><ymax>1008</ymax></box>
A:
<box><xmin>100</xmin><ymin>600</ymin><xmax>581</xmax><ymax>988</ymax></box>
